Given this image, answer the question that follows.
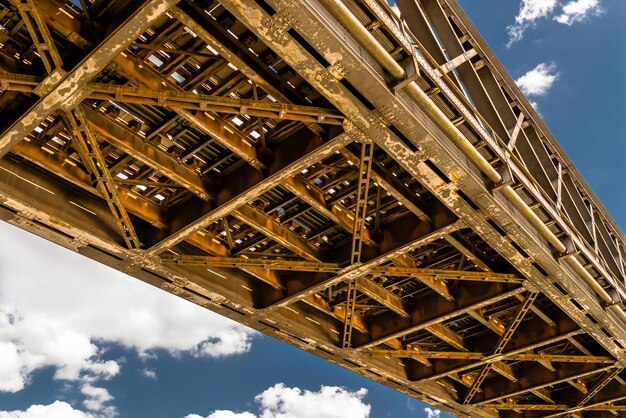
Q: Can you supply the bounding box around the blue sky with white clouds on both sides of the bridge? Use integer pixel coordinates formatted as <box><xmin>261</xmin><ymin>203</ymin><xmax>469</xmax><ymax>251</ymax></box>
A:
<box><xmin>0</xmin><ymin>0</ymin><xmax>626</xmax><ymax>418</ymax></box>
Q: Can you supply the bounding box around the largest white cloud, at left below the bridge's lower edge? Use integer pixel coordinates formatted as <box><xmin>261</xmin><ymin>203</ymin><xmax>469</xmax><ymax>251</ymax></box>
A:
<box><xmin>0</xmin><ymin>223</ymin><xmax>253</xmax><ymax>392</ymax></box>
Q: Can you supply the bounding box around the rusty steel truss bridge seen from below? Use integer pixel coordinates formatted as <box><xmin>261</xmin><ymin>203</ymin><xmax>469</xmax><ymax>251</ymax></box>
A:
<box><xmin>0</xmin><ymin>0</ymin><xmax>626</xmax><ymax>418</ymax></box>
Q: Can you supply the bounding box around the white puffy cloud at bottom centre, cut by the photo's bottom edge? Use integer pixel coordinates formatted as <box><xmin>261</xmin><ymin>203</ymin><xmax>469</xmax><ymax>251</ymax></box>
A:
<box><xmin>185</xmin><ymin>383</ymin><xmax>371</xmax><ymax>418</ymax></box>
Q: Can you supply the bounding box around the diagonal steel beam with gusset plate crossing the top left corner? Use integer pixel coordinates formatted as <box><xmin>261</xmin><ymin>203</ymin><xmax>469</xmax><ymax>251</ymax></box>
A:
<box><xmin>0</xmin><ymin>0</ymin><xmax>178</xmax><ymax>158</ymax></box>
